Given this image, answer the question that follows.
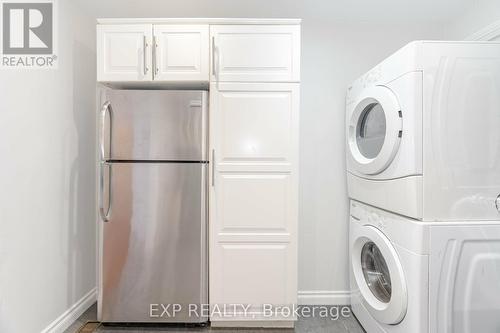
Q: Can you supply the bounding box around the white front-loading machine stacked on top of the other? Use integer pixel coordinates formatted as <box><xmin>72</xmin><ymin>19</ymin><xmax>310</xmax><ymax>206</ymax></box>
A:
<box><xmin>346</xmin><ymin>41</ymin><xmax>500</xmax><ymax>221</ymax></box>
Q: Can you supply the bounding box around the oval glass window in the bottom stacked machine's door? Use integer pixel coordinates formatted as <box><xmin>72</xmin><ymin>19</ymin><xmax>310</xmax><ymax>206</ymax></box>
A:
<box><xmin>361</xmin><ymin>242</ymin><xmax>392</xmax><ymax>303</ymax></box>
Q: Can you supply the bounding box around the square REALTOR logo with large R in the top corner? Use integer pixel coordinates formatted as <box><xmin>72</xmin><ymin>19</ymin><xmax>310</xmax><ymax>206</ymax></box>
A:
<box><xmin>1</xmin><ymin>0</ymin><xmax>57</xmax><ymax>68</ymax></box>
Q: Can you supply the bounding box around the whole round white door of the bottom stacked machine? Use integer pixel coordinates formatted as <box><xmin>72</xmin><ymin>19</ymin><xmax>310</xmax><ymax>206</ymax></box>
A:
<box><xmin>351</xmin><ymin>226</ymin><xmax>408</xmax><ymax>325</ymax></box>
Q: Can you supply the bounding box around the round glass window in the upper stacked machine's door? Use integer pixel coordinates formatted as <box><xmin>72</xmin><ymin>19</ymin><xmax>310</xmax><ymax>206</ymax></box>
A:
<box><xmin>356</xmin><ymin>103</ymin><xmax>386</xmax><ymax>159</ymax></box>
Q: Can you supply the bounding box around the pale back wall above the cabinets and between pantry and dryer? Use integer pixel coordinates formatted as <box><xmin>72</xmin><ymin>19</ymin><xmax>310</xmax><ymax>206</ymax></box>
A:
<box><xmin>74</xmin><ymin>0</ymin><xmax>446</xmax><ymax>303</ymax></box>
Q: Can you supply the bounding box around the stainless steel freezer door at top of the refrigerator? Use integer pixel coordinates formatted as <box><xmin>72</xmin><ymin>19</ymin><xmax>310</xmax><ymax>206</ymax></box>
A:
<box><xmin>101</xmin><ymin>90</ymin><xmax>208</xmax><ymax>161</ymax></box>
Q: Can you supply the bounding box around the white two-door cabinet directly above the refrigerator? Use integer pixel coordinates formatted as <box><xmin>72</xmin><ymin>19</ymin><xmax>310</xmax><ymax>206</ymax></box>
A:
<box><xmin>97</xmin><ymin>24</ymin><xmax>210</xmax><ymax>83</ymax></box>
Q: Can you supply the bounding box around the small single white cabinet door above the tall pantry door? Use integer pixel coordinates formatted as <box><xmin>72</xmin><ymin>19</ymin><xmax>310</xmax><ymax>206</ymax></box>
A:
<box><xmin>210</xmin><ymin>25</ymin><xmax>300</xmax><ymax>82</ymax></box>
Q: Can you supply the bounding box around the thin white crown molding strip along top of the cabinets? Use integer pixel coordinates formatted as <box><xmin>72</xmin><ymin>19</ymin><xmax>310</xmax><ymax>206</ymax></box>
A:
<box><xmin>97</xmin><ymin>17</ymin><xmax>302</xmax><ymax>25</ymax></box>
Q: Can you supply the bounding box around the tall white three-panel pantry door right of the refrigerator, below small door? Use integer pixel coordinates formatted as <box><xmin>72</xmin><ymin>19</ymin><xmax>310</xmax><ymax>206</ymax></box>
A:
<box><xmin>209</xmin><ymin>83</ymin><xmax>299</xmax><ymax>322</ymax></box>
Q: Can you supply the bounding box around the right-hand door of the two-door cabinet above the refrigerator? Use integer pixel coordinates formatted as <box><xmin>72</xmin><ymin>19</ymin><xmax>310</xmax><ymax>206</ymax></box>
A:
<box><xmin>153</xmin><ymin>25</ymin><xmax>210</xmax><ymax>82</ymax></box>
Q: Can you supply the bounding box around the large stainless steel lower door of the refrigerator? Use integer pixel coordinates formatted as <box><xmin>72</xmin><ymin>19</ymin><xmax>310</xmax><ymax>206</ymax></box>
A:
<box><xmin>99</xmin><ymin>163</ymin><xmax>208</xmax><ymax>323</ymax></box>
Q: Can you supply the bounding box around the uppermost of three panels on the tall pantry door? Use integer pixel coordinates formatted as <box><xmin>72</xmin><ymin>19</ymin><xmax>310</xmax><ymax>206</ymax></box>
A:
<box><xmin>212</xmin><ymin>83</ymin><xmax>298</xmax><ymax>170</ymax></box>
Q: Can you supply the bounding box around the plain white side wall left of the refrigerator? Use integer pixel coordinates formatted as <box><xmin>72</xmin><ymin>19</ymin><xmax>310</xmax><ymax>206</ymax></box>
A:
<box><xmin>0</xmin><ymin>0</ymin><xmax>96</xmax><ymax>333</ymax></box>
